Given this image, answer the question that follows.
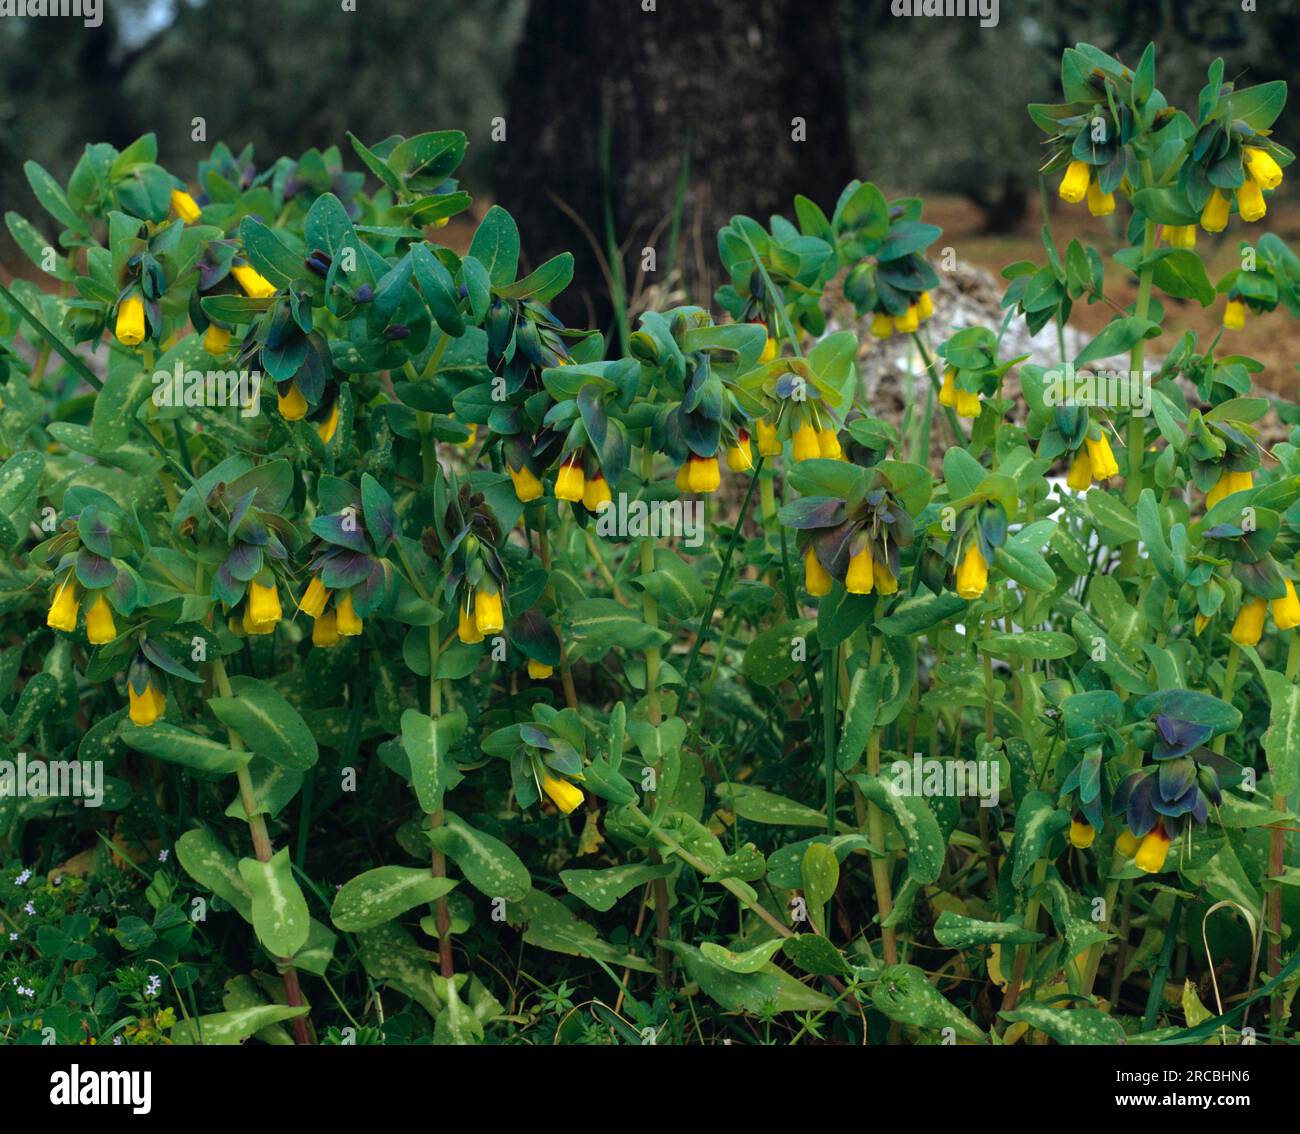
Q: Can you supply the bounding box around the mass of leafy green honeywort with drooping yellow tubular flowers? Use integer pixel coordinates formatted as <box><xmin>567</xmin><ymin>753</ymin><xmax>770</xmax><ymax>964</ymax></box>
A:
<box><xmin>0</xmin><ymin>44</ymin><xmax>1300</xmax><ymax>1044</ymax></box>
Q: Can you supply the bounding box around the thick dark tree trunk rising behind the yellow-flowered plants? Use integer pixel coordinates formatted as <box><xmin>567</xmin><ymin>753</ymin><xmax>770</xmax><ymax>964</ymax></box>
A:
<box><xmin>494</xmin><ymin>0</ymin><xmax>854</xmax><ymax>326</ymax></box>
